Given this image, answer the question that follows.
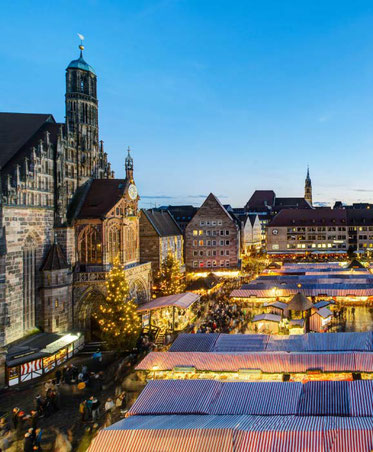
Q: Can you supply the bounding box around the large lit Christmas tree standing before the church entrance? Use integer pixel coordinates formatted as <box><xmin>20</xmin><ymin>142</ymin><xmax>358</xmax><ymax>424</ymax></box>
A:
<box><xmin>93</xmin><ymin>258</ymin><xmax>141</xmax><ymax>350</ymax></box>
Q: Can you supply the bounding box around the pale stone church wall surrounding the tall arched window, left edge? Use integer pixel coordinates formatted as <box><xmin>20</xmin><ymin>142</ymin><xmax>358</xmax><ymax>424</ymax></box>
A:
<box><xmin>0</xmin><ymin>206</ymin><xmax>54</xmax><ymax>345</ymax></box>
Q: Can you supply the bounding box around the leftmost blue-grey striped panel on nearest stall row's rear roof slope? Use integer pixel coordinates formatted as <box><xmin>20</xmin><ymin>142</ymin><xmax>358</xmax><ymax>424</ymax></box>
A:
<box><xmin>128</xmin><ymin>380</ymin><xmax>221</xmax><ymax>415</ymax></box>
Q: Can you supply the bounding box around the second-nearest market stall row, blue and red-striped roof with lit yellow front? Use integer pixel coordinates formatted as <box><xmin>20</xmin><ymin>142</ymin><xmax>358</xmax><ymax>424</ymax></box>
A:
<box><xmin>136</xmin><ymin>332</ymin><xmax>373</xmax><ymax>382</ymax></box>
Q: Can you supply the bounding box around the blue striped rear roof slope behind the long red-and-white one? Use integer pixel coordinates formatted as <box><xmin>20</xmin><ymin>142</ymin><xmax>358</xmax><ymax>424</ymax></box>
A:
<box><xmin>169</xmin><ymin>331</ymin><xmax>373</xmax><ymax>352</ymax></box>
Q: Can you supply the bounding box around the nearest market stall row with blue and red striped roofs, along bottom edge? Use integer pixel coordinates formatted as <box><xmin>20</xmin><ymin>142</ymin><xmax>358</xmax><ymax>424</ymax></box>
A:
<box><xmin>89</xmin><ymin>381</ymin><xmax>373</xmax><ymax>452</ymax></box>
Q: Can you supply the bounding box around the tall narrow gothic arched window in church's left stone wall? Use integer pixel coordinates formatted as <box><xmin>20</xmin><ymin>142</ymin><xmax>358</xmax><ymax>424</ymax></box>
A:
<box><xmin>23</xmin><ymin>236</ymin><xmax>37</xmax><ymax>330</ymax></box>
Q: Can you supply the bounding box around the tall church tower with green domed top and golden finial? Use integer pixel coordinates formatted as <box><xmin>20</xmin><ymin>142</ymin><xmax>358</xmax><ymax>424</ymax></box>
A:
<box><xmin>65</xmin><ymin>37</ymin><xmax>102</xmax><ymax>186</ymax></box>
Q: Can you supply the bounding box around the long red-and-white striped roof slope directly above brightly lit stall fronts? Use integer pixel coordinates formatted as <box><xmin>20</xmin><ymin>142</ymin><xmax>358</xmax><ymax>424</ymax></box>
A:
<box><xmin>136</xmin><ymin>352</ymin><xmax>358</xmax><ymax>373</ymax></box>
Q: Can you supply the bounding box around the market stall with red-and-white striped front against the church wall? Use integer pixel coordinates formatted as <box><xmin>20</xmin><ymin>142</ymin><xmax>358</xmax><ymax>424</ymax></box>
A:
<box><xmin>6</xmin><ymin>333</ymin><xmax>84</xmax><ymax>386</ymax></box>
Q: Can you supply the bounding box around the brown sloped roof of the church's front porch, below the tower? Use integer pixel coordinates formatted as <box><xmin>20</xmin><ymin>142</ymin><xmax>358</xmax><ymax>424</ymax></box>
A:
<box><xmin>76</xmin><ymin>179</ymin><xmax>127</xmax><ymax>218</ymax></box>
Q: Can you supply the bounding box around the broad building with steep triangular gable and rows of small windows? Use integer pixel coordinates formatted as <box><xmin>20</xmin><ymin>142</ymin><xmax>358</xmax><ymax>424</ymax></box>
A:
<box><xmin>184</xmin><ymin>193</ymin><xmax>240</xmax><ymax>270</ymax></box>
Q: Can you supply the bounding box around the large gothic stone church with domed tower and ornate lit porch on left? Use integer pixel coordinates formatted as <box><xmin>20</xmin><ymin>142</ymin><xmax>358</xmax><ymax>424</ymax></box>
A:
<box><xmin>0</xmin><ymin>41</ymin><xmax>151</xmax><ymax>347</ymax></box>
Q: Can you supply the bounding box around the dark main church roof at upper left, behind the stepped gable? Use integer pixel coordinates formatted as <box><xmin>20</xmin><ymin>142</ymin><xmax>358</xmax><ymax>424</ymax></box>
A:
<box><xmin>0</xmin><ymin>113</ymin><xmax>56</xmax><ymax>167</ymax></box>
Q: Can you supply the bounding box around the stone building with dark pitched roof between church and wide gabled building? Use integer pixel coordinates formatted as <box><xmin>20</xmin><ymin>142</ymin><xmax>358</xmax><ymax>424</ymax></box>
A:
<box><xmin>140</xmin><ymin>209</ymin><xmax>184</xmax><ymax>274</ymax></box>
